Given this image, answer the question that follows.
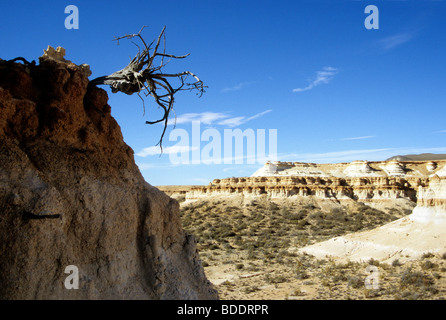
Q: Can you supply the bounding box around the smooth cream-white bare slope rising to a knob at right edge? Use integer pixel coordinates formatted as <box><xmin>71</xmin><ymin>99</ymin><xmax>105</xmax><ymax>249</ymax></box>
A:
<box><xmin>298</xmin><ymin>175</ymin><xmax>446</xmax><ymax>263</ymax></box>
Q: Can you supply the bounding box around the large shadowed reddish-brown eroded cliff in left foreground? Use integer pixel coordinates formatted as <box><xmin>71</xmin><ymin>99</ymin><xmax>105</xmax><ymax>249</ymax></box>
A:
<box><xmin>0</xmin><ymin>48</ymin><xmax>218</xmax><ymax>299</ymax></box>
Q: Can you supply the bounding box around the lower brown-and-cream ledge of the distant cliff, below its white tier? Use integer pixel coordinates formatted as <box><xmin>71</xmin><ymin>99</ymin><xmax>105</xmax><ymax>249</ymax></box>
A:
<box><xmin>179</xmin><ymin>176</ymin><xmax>427</xmax><ymax>206</ymax></box>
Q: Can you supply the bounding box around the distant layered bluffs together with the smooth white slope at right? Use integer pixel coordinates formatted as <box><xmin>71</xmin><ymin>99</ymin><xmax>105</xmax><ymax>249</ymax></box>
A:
<box><xmin>160</xmin><ymin>160</ymin><xmax>446</xmax><ymax>262</ymax></box>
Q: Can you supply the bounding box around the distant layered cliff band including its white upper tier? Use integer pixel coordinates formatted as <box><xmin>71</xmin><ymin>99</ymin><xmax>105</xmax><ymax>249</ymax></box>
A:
<box><xmin>176</xmin><ymin>160</ymin><xmax>446</xmax><ymax>209</ymax></box>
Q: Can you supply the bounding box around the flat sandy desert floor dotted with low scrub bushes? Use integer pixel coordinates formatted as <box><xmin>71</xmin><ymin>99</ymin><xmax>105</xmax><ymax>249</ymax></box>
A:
<box><xmin>178</xmin><ymin>197</ymin><xmax>446</xmax><ymax>300</ymax></box>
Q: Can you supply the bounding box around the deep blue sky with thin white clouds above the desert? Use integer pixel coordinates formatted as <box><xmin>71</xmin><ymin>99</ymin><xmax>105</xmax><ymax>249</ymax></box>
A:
<box><xmin>0</xmin><ymin>0</ymin><xmax>446</xmax><ymax>185</ymax></box>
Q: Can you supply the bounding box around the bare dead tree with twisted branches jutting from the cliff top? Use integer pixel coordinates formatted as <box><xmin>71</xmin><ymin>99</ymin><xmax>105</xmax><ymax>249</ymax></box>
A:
<box><xmin>90</xmin><ymin>26</ymin><xmax>206</xmax><ymax>151</ymax></box>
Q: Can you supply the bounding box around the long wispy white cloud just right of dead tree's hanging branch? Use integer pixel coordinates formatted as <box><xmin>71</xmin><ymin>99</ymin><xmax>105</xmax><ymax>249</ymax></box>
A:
<box><xmin>169</xmin><ymin>109</ymin><xmax>272</xmax><ymax>127</ymax></box>
